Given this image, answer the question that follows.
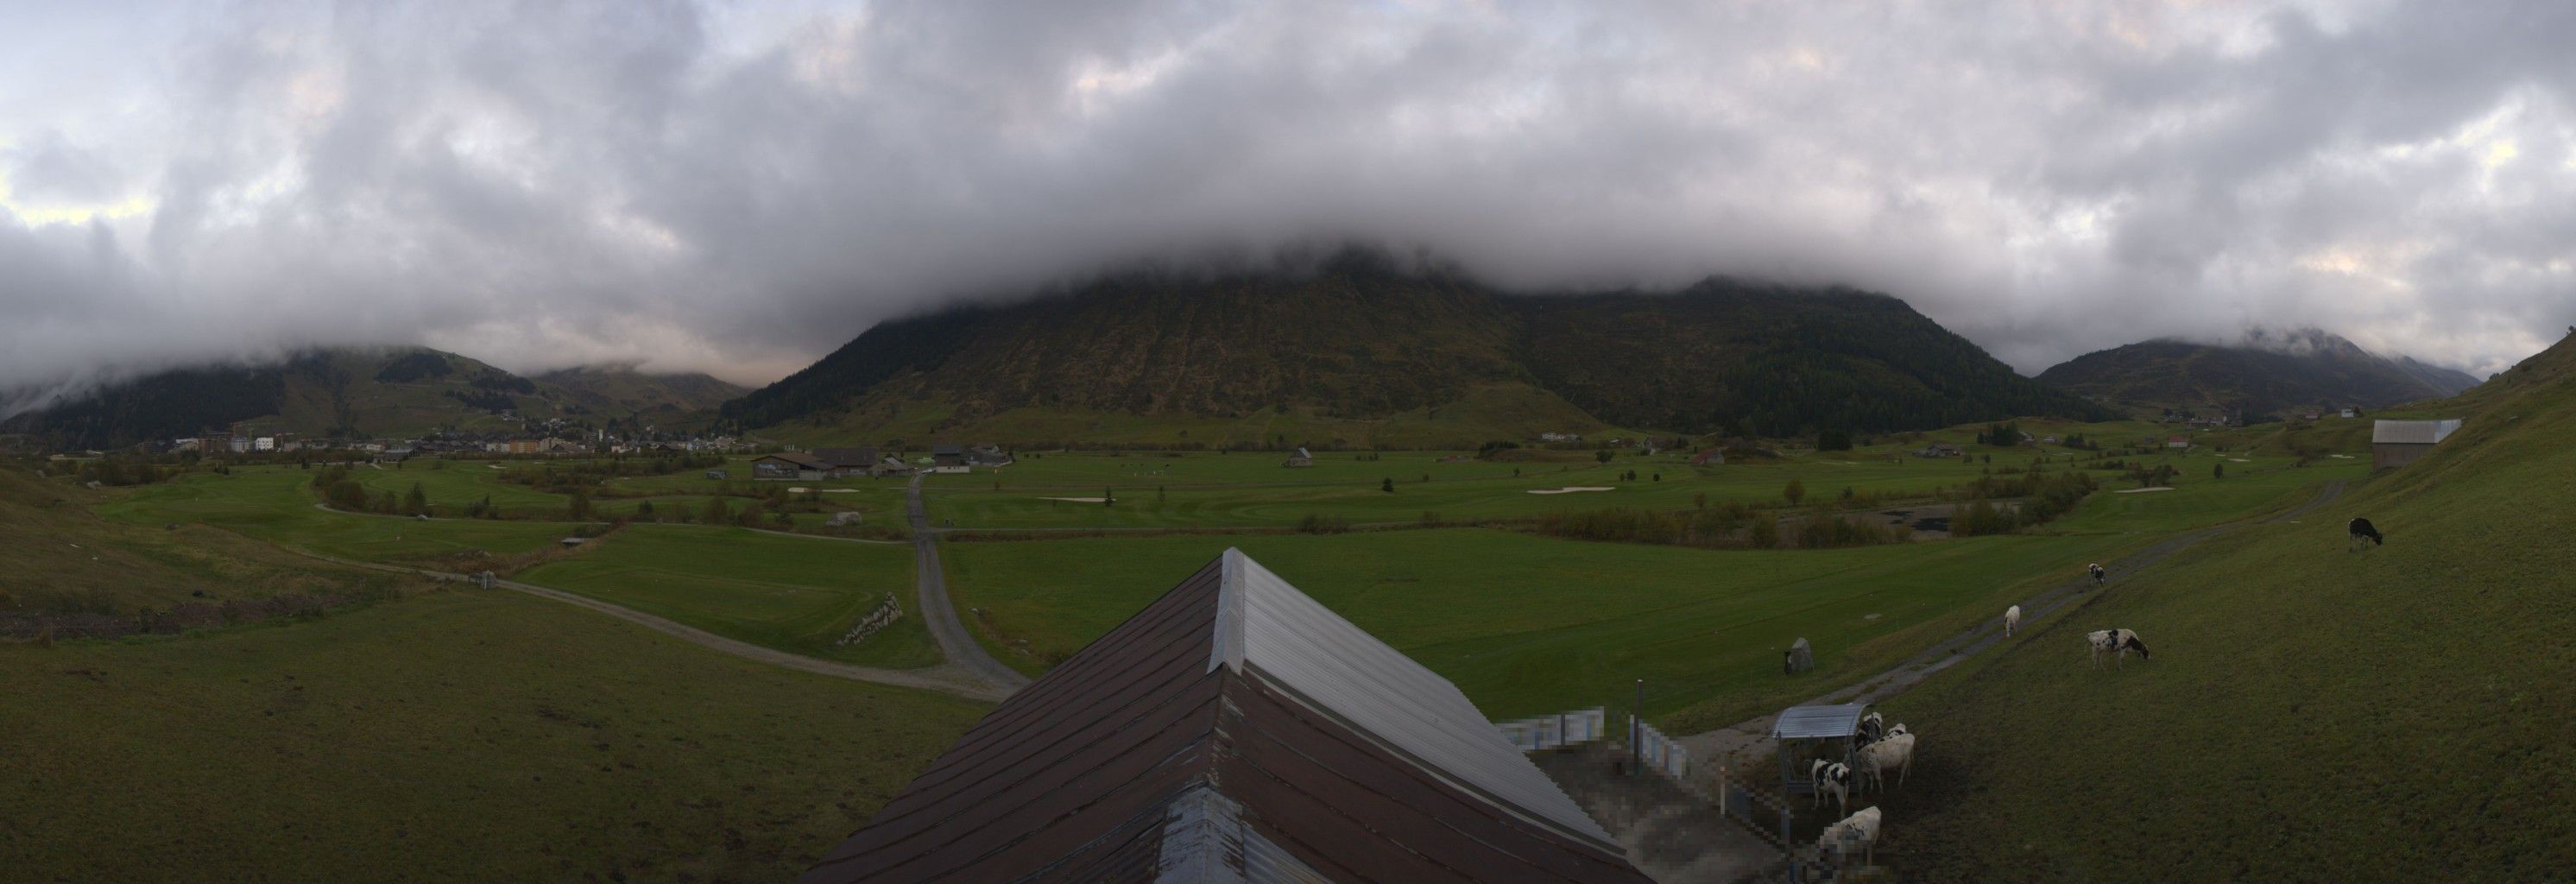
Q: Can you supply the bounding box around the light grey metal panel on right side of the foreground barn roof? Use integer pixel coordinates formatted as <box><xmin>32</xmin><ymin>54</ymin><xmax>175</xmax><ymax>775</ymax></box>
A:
<box><xmin>1208</xmin><ymin>549</ymin><xmax>1618</xmax><ymax>845</ymax></box>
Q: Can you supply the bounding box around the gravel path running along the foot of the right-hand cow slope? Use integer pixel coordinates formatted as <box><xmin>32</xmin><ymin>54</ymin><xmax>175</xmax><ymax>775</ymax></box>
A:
<box><xmin>1680</xmin><ymin>479</ymin><xmax>2344</xmax><ymax>771</ymax></box>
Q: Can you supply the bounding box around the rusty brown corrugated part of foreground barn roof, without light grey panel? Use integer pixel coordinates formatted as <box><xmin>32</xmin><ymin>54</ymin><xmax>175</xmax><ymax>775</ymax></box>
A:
<box><xmin>801</xmin><ymin>552</ymin><xmax>1646</xmax><ymax>884</ymax></box>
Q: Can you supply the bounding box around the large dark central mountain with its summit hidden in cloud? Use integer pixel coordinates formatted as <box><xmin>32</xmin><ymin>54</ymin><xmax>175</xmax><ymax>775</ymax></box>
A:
<box><xmin>724</xmin><ymin>253</ymin><xmax>2102</xmax><ymax>445</ymax></box>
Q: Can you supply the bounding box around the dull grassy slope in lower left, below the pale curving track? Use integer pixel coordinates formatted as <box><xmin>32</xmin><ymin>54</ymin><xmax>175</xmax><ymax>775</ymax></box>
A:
<box><xmin>0</xmin><ymin>590</ymin><xmax>989</xmax><ymax>881</ymax></box>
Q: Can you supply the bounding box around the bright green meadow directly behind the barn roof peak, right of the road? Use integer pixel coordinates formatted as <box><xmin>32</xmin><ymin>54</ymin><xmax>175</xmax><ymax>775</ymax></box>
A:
<box><xmin>943</xmin><ymin>451</ymin><xmax>2332</xmax><ymax>732</ymax></box>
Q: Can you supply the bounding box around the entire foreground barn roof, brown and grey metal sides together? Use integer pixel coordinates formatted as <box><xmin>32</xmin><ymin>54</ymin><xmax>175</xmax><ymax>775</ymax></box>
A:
<box><xmin>799</xmin><ymin>549</ymin><xmax>1649</xmax><ymax>884</ymax></box>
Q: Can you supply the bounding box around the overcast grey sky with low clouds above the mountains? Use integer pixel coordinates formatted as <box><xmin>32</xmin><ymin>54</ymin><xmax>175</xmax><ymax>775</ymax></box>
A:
<box><xmin>0</xmin><ymin>0</ymin><xmax>2576</xmax><ymax>401</ymax></box>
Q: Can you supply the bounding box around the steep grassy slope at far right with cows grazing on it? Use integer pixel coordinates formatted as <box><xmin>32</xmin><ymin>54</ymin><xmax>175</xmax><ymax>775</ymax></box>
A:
<box><xmin>1883</xmin><ymin>345</ymin><xmax>2576</xmax><ymax>881</ymax></box>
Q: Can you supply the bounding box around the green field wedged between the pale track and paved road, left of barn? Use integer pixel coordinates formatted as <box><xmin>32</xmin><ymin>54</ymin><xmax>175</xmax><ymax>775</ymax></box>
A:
<box><xmin>515</xmin><ymin>526</ymin><xmax>940</xmax><ymax>667</ymax></box>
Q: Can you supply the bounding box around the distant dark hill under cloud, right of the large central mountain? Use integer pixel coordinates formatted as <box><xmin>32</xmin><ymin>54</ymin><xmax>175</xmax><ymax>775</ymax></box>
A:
<box><xmin>2040</xmin><ymin>330</ymin><xmax>2478</xmax><ymax>418</ymax></box>
